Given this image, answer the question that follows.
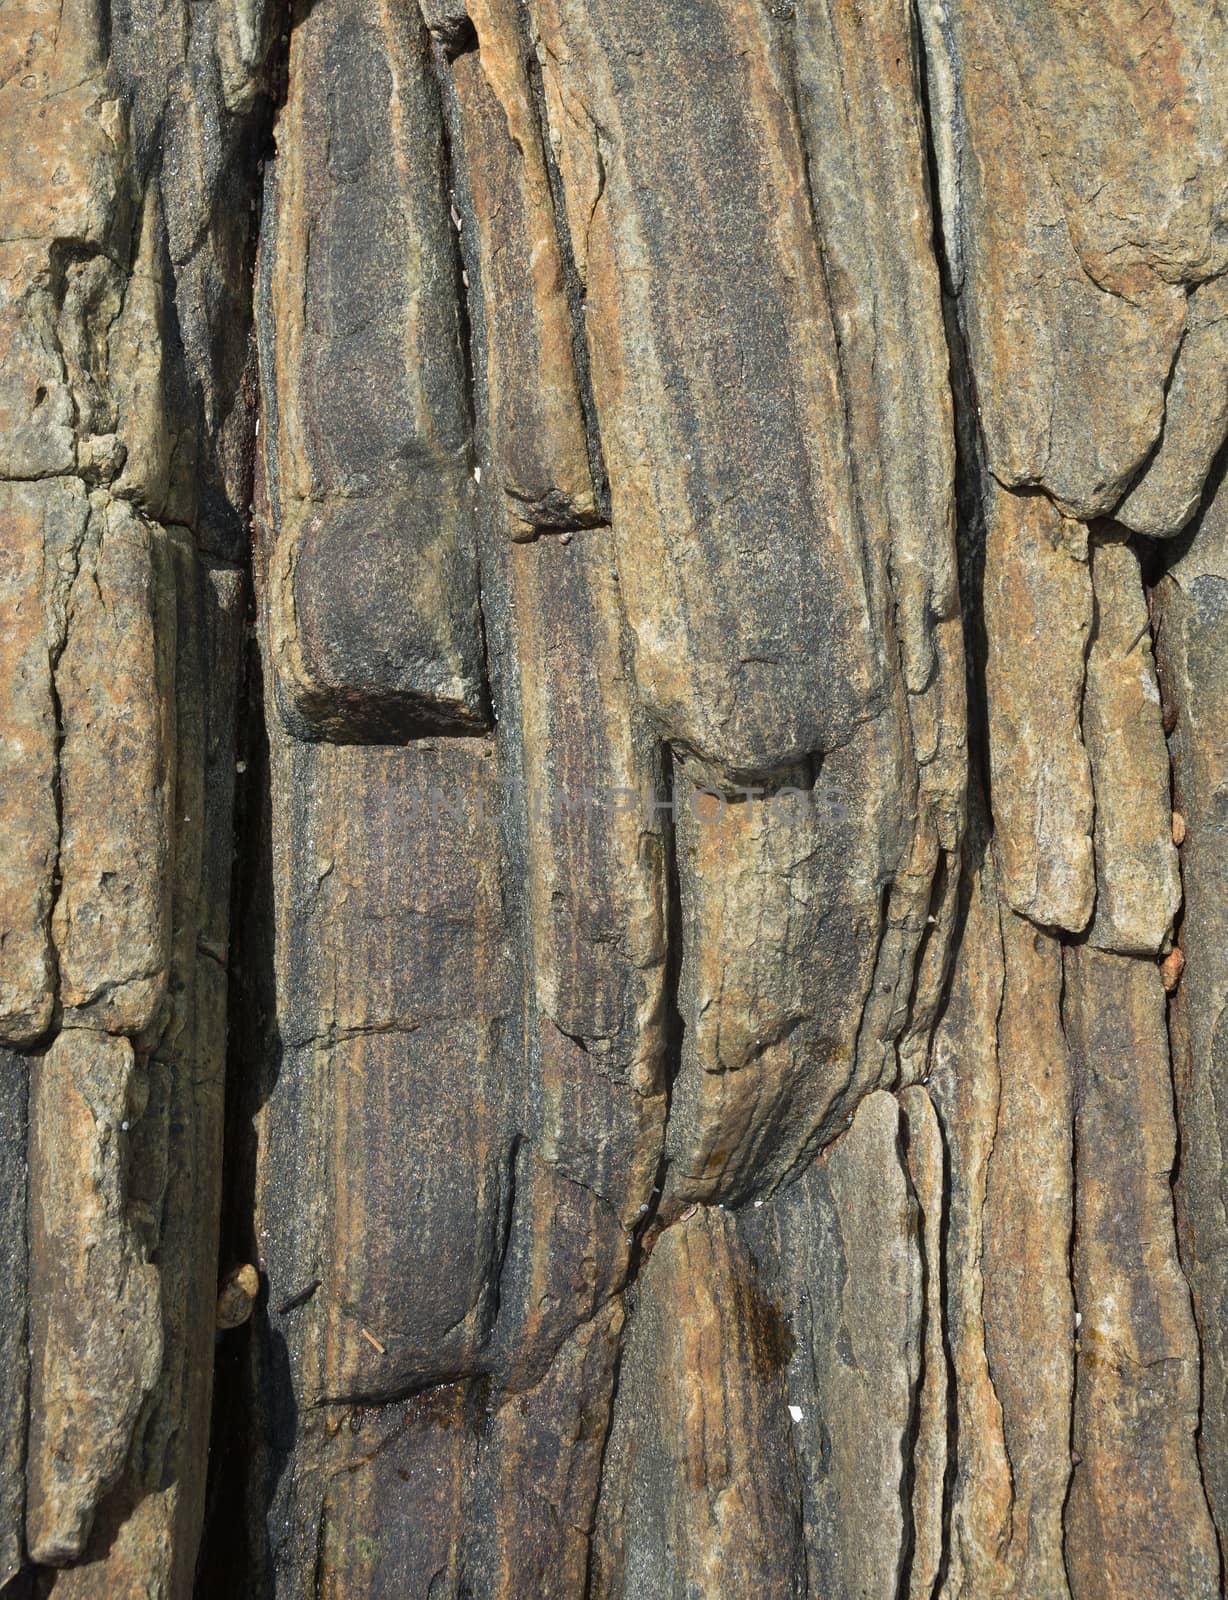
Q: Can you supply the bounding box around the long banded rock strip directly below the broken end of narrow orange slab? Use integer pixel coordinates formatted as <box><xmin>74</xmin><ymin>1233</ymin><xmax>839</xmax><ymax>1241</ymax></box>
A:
<box><xmin>486</xmin><ymin>526</ymin><xmax>672</xmax><ymax>1389</ymax></box>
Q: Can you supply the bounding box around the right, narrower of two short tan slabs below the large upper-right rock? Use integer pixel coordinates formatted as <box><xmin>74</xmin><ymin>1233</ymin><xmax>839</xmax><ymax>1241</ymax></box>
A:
<box><xmin>1082</xmin><ymin>542</ymin><xmax>1182</xmax><ymax>954</ymax></box>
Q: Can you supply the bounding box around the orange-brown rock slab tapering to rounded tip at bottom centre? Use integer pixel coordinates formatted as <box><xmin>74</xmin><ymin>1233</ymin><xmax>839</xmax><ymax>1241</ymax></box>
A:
<box><xmin>592</xmin><ymin>1208</ymin><xmax>801</xmax><ymax>1600</ymax></box>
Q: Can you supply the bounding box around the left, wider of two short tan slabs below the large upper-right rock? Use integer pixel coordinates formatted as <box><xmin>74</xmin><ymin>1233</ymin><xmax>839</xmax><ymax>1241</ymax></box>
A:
<box><xmin>985</xmin><ymin>490</ymin><xmax>1095</xmax><ymax>933</ymax></box>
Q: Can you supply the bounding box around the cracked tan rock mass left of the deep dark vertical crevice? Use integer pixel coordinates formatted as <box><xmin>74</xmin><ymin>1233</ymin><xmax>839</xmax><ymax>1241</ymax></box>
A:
<box><xmin>0</xmin><ymin>0</ymin><xmax>259</xmax><ymax>1597</ymax></box>
